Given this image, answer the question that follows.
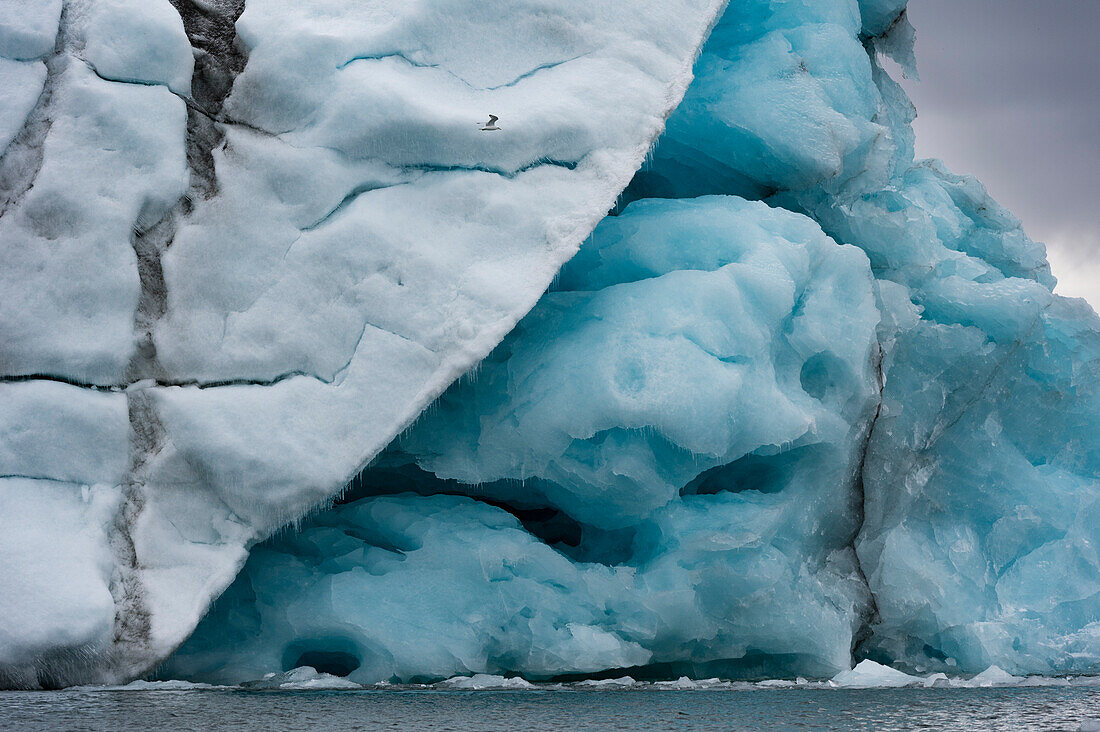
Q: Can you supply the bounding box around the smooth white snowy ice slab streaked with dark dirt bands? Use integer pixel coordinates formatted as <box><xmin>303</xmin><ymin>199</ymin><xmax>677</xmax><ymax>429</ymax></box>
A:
<box><xmin>0</xmin><ymin>0</ymin><xmax>723</xmax><ymax>687</ymax></box>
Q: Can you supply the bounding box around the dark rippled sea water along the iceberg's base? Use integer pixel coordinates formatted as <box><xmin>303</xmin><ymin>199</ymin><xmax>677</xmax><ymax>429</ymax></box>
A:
<box><xmin>0</xmin><ymin>687</ymin><xmax>1100</xmax><ymax>732</ymax></box>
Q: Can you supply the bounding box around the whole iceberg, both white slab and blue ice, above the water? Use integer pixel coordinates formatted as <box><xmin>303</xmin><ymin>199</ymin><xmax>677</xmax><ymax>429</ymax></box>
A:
<box><xmin>0</xmin><ymin>0</ymin><xmax>1100</xmax><ymax>688</ymax></box>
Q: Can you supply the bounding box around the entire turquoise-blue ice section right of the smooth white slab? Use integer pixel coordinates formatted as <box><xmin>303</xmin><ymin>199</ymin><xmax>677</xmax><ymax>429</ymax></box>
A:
<box><xmin>165</xmin><ymin>0</ymin><xmax>1100</xmax><ymax>686</ymax></box>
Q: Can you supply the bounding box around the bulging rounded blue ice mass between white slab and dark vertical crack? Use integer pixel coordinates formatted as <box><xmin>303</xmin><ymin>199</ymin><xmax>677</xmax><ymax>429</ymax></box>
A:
<box><xmin>165</xmin><ymin>196</ymin><xmax>879</xmax><ymax>681</ymax></box>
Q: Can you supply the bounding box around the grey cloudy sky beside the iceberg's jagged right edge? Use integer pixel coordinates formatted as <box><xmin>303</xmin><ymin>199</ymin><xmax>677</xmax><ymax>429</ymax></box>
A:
<box><xmin>904</xmin><ymin>0</ymin><xmax>1100</xmax><ymax>308</ymax></box>
